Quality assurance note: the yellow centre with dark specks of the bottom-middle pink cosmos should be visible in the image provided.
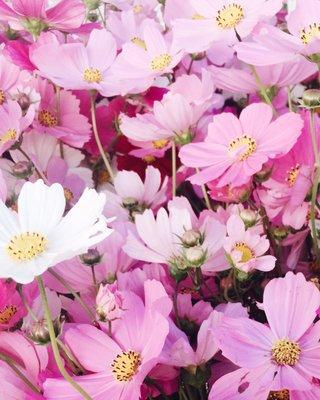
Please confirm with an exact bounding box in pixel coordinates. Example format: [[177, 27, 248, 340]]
[[111, 350, 141, 382]]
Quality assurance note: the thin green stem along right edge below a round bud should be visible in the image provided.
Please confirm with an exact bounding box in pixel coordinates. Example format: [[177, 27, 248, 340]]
[[310, 110, 320, 265]]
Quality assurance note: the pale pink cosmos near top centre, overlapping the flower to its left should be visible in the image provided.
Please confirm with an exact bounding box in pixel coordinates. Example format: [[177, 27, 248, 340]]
[[112, 23, 183, 95]]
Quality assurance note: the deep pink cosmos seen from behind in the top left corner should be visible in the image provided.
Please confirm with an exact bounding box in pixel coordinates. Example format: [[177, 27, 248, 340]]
[[0, 0, 85, 35]]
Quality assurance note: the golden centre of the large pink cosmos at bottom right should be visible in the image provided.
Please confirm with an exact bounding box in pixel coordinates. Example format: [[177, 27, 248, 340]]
[[271, 339, 301, 367]]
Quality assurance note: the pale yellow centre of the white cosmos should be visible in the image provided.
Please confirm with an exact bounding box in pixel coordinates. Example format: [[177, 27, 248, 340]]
[[6, 232, 47, 261]]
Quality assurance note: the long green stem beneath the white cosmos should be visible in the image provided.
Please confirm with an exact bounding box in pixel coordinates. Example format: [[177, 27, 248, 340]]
[[37, 276, 92, 400]]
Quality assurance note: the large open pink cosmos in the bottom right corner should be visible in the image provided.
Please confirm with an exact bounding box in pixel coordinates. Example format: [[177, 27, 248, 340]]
[[216, 272, 320, 391]]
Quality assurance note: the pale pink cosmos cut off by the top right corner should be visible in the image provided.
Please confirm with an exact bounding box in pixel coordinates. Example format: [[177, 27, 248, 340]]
[[235, 0, 320, 65]]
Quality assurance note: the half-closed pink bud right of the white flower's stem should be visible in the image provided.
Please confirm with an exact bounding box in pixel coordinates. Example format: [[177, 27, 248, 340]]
[[96, 284, 124, 321]]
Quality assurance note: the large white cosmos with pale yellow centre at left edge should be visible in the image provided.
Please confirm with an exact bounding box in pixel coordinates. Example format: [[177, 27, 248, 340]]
[[0, 180, 112, 283]]
